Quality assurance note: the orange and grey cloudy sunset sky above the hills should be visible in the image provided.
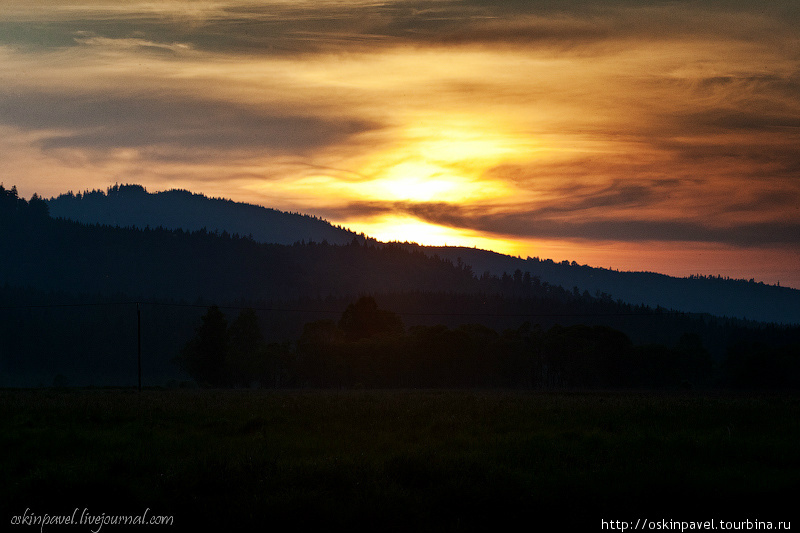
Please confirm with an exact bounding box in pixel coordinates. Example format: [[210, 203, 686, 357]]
[[0, 0, 800, 288]]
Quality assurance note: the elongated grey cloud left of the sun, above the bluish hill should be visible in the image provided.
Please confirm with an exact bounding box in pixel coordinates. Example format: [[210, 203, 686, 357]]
[[0, 92, 375, 158]]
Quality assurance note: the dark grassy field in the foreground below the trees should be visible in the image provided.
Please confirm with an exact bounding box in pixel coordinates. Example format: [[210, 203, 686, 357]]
[[0, 390, 800, 531]]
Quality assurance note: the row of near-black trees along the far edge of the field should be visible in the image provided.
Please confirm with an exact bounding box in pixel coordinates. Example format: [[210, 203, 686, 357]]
[[176, 297, 800, 389]]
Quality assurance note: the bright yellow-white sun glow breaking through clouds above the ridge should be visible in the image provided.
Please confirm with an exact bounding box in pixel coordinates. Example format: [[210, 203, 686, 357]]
[[245, 115, 542, 249]]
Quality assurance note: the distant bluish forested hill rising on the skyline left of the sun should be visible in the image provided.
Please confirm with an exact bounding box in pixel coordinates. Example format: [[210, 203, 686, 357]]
[[47, 185, 364, 244]]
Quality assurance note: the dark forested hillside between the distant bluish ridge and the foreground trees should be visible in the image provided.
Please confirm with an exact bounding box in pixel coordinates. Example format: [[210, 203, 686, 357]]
[[0, 186, 798, 386]]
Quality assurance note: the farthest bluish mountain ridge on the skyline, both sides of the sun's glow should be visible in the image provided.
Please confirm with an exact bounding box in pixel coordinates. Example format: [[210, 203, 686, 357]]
[[47, 185, 800, 324]]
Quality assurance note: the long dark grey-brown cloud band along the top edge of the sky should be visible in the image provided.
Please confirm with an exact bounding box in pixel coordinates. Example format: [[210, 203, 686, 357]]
[[0, 0, 800, 54]]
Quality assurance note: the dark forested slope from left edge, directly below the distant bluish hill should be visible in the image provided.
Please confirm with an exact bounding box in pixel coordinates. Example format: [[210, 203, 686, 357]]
[[0, 199, 478, 302]]
